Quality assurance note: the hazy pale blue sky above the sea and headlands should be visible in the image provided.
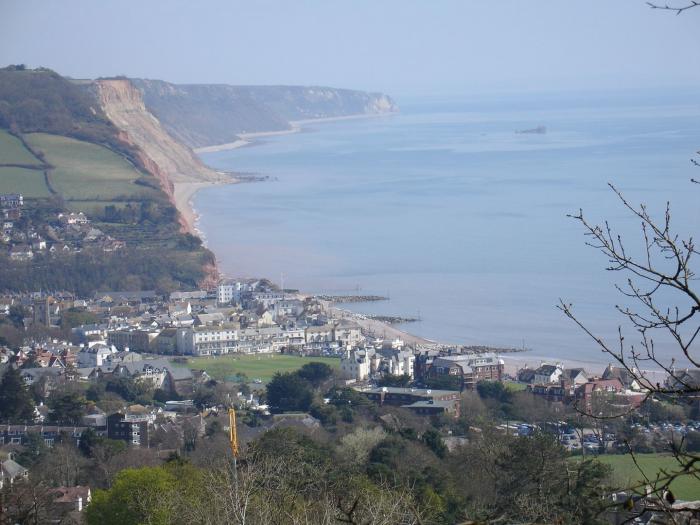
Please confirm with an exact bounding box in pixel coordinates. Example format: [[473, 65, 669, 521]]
[[0, 0, 700, 94]]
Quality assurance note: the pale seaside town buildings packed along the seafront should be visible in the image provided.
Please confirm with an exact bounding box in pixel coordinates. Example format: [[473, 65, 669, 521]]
[[0, 278, 680, 454]]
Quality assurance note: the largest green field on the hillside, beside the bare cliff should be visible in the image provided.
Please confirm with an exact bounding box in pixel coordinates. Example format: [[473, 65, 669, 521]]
[[25, 133, 155, 202]]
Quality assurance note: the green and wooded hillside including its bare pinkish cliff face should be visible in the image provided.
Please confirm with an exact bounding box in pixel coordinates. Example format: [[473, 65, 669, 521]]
[[0, 66, 223, 295]]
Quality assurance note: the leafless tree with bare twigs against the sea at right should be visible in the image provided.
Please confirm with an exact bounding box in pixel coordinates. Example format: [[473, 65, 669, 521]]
[[559, 185, 700, 510]]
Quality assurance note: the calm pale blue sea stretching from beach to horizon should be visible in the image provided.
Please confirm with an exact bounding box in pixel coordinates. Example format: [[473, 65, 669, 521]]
[[195, 95, 700, 361]]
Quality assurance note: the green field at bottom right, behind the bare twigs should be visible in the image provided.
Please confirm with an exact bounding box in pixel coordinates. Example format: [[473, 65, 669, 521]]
[[598, 454, 700, 500]]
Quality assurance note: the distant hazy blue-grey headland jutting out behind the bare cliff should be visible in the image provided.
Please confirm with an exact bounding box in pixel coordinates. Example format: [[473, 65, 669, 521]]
[[132, 79, 398, 148]]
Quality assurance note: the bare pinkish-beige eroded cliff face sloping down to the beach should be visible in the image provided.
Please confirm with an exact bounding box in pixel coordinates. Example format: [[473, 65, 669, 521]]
[[96, 79, 226, 186]]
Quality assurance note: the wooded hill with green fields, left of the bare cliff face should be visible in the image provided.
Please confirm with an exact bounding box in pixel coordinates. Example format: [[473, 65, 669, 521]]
[[0, 66, 213, 294]]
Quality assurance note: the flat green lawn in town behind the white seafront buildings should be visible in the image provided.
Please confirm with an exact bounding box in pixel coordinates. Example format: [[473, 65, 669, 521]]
[[178, 354, 340, 382]]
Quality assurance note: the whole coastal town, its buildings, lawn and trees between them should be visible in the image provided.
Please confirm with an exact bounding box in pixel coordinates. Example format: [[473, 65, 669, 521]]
[[0, 270, 700, 513]]
